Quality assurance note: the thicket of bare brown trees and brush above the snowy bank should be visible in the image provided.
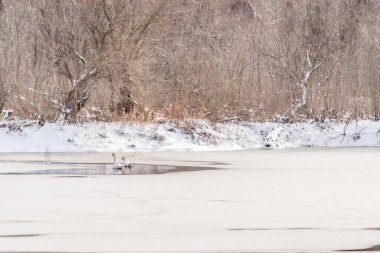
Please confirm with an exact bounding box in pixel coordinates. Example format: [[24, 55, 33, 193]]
[[0, 0, 380, 121]]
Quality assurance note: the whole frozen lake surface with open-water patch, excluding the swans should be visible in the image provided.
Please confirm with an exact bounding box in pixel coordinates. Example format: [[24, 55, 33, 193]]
[[0, 148, 380, 252]]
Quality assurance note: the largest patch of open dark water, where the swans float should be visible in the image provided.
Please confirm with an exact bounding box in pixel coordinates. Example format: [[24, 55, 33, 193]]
[[0, 163, 218, 177]]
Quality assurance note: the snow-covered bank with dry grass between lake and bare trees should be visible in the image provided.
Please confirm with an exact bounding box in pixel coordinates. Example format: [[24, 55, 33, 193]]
[[0, 120, 380, 152]]
